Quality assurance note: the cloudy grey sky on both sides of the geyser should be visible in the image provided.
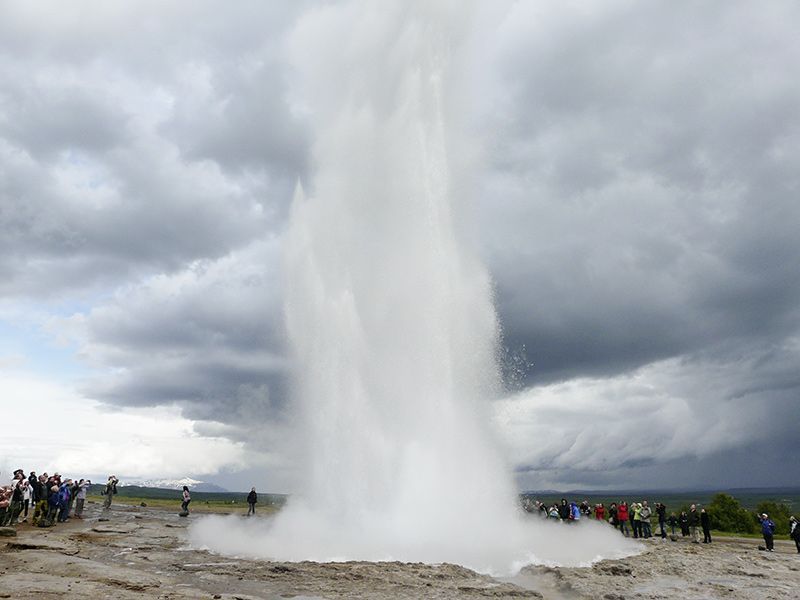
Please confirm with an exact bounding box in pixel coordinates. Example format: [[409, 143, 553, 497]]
[[0, 0, 800, 492]]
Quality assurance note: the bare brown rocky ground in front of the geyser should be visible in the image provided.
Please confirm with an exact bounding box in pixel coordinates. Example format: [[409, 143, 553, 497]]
[[0, 505, 800, 600]]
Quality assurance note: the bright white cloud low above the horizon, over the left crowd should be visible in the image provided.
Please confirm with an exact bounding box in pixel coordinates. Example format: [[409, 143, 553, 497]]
[[0, 371, 247, 477]]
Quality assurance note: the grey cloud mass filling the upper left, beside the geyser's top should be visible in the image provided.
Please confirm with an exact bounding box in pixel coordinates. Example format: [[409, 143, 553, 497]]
[[0, 2, 306, 296]]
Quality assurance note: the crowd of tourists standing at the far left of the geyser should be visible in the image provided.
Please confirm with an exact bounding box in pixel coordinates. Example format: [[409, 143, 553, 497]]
[[0, 469, 118, 527]]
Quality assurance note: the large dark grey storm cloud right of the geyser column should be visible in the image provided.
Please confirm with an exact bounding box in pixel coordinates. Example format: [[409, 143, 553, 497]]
[[478, 3, 800, 382]]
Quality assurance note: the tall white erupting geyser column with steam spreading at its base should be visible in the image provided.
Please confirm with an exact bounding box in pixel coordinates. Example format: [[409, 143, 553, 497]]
[[192, 2, 630, 572]]
